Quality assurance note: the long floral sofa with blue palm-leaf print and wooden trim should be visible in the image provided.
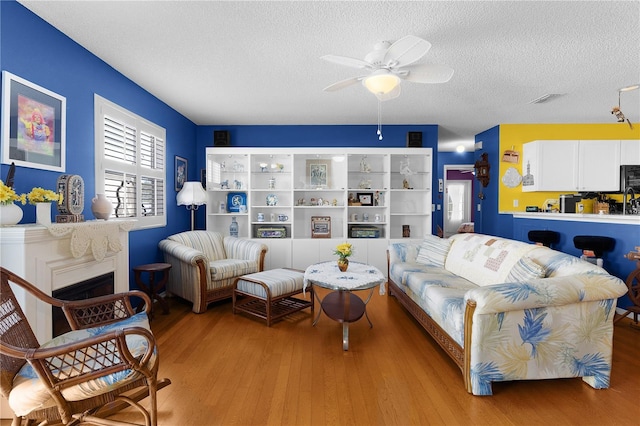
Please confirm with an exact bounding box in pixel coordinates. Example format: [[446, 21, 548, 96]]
[[387, 233, 627, 395]]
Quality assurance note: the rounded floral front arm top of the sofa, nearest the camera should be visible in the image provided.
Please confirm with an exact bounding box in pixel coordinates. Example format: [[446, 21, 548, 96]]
[[465, 274, 627, 314]]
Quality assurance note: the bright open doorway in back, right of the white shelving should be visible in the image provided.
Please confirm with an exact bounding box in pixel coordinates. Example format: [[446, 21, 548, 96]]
[[442, 164, 474, 238]]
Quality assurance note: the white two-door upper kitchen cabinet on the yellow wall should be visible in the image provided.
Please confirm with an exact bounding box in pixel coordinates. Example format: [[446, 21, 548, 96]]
[[522, 140, 621, 192]]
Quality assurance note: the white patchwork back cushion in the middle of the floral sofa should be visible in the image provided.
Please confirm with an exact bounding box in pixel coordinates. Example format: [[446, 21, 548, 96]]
[[445, 234, 537, 286]]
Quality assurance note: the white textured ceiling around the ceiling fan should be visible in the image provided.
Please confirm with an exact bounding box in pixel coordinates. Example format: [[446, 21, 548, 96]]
[[19, 0, 640, 151]]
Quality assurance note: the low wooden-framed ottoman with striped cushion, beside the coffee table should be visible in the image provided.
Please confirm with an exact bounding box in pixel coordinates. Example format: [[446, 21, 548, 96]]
[[232, 268, 313, 327]]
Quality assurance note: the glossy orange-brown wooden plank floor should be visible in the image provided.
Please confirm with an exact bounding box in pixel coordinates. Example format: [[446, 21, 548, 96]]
[[7, 291, 640, 425]]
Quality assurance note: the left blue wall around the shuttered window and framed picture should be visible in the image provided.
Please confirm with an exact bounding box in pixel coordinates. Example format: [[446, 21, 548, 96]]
[[0, 1, 200, 280]]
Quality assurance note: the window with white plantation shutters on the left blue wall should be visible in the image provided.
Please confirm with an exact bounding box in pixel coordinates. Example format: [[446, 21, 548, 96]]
[[94, 95, 166, 228]]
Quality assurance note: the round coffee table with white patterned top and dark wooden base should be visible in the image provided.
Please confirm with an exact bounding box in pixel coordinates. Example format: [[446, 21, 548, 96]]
[[304, 261, 386, 351]]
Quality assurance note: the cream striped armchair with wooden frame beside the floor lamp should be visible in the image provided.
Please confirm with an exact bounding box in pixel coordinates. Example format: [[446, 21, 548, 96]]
[[158, 231, 267, 314]]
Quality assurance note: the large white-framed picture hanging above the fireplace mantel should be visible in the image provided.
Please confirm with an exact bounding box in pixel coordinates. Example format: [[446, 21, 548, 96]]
[[1, 71, 67, 172]]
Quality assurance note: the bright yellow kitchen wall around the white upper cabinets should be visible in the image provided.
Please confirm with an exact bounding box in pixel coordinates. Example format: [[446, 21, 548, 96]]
[[498, 123, 640, 212]]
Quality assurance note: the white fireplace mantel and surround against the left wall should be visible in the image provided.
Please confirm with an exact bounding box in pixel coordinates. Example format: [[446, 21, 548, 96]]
[[0, 219, 136, 343]]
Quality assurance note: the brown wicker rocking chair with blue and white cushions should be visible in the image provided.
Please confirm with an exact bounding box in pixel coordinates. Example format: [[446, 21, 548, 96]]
[[0, 267, 171, 426]]
